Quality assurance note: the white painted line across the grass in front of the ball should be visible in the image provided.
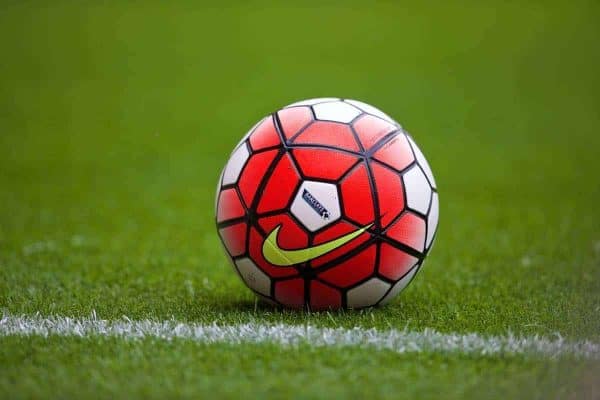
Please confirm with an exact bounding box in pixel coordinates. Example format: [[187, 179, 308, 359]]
[[0, 314, 600, 359]]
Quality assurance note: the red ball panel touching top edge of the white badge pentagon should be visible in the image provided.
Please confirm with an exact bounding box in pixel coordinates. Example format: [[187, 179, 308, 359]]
[[292, 148, 358, 180]]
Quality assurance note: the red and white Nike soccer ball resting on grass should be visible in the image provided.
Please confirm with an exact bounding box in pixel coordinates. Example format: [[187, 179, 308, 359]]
[[216, 98, 439, 310]]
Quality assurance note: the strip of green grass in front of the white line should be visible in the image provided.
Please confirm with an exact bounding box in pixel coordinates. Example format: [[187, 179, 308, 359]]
[[0, 337, 600, 399]]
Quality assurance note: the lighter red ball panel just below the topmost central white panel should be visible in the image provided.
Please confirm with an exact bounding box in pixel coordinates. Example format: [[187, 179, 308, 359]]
[[294, 121, 359, 151]]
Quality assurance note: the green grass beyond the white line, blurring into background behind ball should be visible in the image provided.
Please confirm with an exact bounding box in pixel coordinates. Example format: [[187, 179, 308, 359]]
[[0, 1, 600, 336]]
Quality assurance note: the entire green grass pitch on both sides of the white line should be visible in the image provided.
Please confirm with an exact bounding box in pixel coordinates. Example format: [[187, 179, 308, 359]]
[[0, 1, 600, 399]]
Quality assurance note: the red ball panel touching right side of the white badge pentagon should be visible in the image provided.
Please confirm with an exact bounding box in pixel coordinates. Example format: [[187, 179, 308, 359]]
[[341, 164, 375, 225]]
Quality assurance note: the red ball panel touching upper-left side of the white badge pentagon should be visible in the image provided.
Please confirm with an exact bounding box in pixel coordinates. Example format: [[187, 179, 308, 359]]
[[257, 154, 300, 213]]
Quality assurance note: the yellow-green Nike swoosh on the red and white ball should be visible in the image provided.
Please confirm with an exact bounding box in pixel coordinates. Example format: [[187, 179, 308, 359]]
[[262, 224, 373, 267]]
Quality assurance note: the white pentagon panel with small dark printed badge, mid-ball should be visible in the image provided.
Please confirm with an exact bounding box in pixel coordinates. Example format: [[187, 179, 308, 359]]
[[291, 181, 341, 232]]
